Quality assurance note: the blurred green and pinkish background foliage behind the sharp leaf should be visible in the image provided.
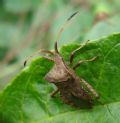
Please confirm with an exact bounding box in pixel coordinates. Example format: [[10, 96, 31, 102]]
[[0, 0, 120, 88]]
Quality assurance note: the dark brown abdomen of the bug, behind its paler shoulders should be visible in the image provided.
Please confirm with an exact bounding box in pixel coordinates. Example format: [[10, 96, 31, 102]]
[[56, 79, 92, 108]]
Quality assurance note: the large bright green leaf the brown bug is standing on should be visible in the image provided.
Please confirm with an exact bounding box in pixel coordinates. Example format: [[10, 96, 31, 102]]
[[0, 33, 120, 123]]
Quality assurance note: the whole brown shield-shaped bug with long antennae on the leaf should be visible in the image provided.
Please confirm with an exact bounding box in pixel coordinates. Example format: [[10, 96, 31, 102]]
[[24, 12, 99, 108]]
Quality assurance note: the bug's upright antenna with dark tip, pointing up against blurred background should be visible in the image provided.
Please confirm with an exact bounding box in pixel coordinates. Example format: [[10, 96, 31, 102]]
[[54, 11, 78, 53]]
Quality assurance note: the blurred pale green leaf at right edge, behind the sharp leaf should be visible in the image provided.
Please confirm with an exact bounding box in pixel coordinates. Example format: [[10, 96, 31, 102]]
[[84, 14, 120, 40]]
